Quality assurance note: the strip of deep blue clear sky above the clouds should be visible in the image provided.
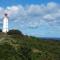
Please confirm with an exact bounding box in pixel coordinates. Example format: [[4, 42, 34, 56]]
[[0, 0, 60, 7]]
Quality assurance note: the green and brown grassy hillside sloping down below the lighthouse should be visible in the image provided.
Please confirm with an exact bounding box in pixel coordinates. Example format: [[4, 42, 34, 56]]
[[0, 30, 60, 60]]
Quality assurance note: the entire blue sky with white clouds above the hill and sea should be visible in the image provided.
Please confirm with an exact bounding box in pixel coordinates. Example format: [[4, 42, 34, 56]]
[[0, 0, 60, 38]]
